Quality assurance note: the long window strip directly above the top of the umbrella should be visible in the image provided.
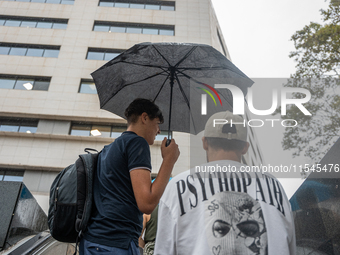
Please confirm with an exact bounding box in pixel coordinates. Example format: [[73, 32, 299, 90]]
[[93, 21, 175, 36]]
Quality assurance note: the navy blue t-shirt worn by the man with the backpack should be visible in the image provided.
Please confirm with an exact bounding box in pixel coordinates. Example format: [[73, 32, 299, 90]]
[[84, 131, 151, 249]]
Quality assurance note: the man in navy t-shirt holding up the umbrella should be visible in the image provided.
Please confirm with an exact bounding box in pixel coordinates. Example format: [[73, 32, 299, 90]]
[[79, 99, 179, 255]]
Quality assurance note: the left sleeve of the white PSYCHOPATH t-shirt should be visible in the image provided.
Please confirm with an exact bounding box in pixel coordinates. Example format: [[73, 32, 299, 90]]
[[154, 200, 177, 255]]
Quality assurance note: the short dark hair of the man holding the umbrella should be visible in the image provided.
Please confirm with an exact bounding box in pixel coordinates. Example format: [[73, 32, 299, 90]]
[[124, 98, 164, 125]]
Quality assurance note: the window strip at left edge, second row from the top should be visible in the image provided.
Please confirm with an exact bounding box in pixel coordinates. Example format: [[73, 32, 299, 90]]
[[0, 15, 67, 29]]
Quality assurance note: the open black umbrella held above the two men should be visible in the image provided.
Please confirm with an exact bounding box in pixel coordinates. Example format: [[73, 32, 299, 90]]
[[91, 43, 253, 138]]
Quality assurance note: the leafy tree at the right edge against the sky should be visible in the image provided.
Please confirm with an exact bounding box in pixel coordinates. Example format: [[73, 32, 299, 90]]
[[276, 0, 340, 162]]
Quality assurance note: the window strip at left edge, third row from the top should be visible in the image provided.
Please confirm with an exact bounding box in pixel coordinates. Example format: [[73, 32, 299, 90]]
[[0, 43, 60, 58]]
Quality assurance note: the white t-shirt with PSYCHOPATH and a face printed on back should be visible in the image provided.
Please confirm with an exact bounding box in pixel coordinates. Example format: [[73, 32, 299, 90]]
[[155, 160, 296, 255]]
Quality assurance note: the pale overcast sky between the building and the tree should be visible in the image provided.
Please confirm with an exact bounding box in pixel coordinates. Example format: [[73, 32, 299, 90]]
[[212, 0, 328, 198]]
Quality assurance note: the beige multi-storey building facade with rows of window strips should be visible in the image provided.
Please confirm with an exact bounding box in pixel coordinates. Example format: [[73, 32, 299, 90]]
[[0, 0, 262, 211]]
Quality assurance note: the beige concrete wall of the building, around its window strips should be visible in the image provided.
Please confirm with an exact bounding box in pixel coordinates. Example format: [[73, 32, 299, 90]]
[[0, 0, 234, 213]]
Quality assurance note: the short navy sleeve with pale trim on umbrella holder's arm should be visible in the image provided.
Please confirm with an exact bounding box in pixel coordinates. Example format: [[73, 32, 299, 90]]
[[127, 137, 151, 172]]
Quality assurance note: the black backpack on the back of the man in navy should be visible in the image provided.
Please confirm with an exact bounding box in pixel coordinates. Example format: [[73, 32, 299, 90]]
[[48, 148, 100, 247]]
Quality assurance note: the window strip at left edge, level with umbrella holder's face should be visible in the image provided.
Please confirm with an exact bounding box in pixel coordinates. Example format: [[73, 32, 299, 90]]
[[0, 117, 38, 134]]
